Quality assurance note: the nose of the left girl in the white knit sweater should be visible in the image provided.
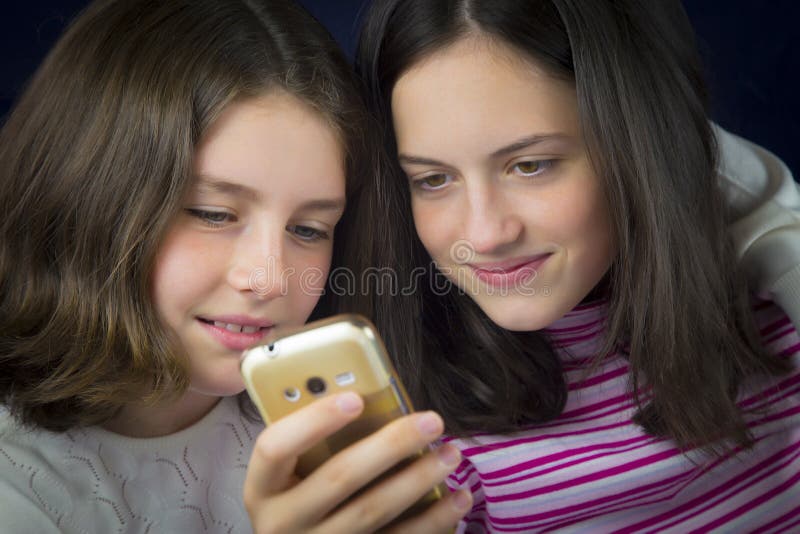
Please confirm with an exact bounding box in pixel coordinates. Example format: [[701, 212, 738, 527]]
[[228, 224, 292, 300]]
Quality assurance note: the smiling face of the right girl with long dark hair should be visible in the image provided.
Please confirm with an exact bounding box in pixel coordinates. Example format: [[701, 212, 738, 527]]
[[391, 38, 614, 331]]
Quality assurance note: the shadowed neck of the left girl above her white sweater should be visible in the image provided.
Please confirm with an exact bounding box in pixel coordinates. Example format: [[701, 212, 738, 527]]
[[101, 390, 221, 438]]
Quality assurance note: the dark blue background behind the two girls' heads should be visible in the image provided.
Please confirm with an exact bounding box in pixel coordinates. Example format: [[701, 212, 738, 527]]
[[0, 0, 800, 178]]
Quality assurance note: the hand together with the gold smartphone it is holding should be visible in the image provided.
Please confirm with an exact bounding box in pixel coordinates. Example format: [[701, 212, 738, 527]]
[[242, 316, 470, 532]]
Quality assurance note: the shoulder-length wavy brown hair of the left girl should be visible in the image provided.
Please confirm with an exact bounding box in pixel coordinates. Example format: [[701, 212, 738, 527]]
[[0, 0, 374, 430]]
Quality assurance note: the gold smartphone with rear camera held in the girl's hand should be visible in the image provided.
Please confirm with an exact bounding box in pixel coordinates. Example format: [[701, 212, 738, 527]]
[[241, 315, 447, 521]]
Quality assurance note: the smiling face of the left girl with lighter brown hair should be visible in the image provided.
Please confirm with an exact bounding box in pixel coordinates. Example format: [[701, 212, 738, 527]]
[[153, 93, 345, 398]]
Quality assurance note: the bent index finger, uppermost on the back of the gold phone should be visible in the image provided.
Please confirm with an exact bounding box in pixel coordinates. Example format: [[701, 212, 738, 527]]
[[245, 392, 364, 502]]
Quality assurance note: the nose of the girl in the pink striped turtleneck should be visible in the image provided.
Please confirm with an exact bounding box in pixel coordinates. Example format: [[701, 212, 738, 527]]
[[464, 182, 523, 255]]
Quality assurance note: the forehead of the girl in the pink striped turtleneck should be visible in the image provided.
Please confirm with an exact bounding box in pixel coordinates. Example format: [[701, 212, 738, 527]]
[[392, 38, 579, 153]]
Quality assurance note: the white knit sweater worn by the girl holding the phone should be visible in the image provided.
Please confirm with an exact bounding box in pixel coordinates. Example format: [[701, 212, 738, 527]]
[[0, 397, 263, 534]]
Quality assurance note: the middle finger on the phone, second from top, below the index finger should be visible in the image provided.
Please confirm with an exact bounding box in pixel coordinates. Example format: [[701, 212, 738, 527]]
[[291, 412, 444, 519]]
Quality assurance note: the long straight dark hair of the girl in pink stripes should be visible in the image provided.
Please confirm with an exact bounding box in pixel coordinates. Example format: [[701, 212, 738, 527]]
[[357, 0, 786, 448]]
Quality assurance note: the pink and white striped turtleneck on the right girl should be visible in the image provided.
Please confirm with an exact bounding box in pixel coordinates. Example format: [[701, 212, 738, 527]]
[[448, 302, 800, 533]]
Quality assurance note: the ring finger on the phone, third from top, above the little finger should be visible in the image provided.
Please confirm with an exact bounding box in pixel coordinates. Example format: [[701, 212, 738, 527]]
[[312, 444, 461, 532]]
